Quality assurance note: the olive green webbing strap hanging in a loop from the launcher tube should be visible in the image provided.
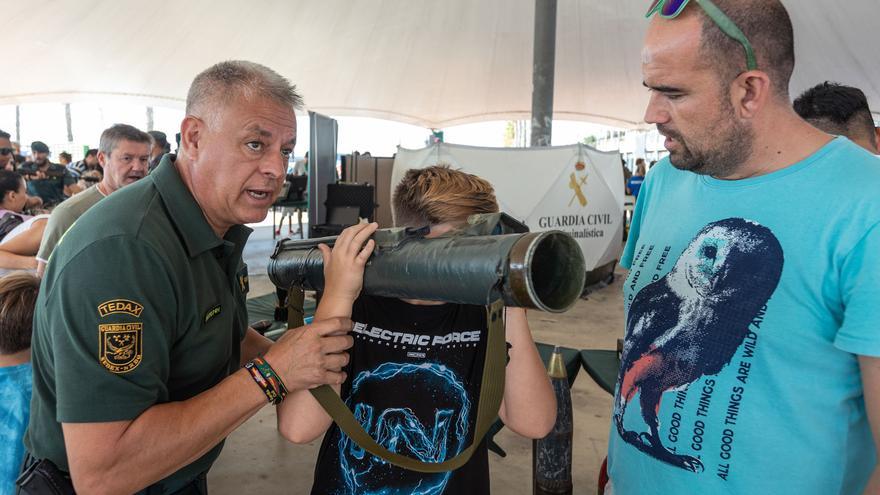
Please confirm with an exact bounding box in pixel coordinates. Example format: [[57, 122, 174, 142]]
[[311, 300, 507, 473]]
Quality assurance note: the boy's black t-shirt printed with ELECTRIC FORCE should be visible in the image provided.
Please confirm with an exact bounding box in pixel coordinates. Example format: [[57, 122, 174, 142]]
[[312, 295, 489, 495]]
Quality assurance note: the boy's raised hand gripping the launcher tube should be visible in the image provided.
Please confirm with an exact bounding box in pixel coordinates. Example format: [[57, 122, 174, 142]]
[[318, 222, 379, 308]]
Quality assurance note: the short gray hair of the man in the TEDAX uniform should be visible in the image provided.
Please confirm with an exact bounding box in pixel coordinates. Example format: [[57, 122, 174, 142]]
[[186, 60, 303, 115]]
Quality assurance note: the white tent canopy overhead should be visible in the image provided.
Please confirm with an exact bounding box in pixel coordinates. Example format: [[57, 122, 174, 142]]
[[0, 0, 880, 128]]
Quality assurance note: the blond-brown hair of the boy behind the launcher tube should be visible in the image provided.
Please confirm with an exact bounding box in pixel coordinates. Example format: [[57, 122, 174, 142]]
[[391, 165, 498, 227]]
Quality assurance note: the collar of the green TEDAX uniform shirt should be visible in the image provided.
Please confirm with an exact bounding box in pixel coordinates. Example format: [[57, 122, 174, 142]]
[[150, 153, 253, 257]]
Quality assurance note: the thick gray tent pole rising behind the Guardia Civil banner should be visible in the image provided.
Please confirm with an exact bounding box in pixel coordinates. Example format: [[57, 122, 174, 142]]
[[532, 0, 556, 147]]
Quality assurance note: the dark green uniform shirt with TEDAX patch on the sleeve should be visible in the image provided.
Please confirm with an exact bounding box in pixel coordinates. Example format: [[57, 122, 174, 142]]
[[25, 155, 251, 489]]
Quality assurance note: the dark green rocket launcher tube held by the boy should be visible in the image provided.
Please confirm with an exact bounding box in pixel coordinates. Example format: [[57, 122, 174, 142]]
[[269, 214, 586, 313]]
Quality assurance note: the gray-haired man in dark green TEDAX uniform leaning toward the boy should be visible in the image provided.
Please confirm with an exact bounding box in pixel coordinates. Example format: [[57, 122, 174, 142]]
[[25, 62, 352, 494]]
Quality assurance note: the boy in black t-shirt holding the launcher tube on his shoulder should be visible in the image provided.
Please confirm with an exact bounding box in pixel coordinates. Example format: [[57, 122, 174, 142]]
[[278, 165, 556, 495]]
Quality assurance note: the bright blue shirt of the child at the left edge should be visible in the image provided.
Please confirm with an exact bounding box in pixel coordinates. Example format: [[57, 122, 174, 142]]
[[0, 363, 33, 495]]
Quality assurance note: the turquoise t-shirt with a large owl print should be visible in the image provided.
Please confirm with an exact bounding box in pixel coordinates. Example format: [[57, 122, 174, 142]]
[[608, 138, 880, 495]]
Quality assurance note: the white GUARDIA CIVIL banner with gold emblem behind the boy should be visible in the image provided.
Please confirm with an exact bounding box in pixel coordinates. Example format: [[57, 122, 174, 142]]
[[391, 143, 624, 270]]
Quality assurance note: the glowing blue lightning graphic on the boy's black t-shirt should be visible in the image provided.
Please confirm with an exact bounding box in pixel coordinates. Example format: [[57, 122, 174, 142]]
[[338, 363, 471, 495]]
